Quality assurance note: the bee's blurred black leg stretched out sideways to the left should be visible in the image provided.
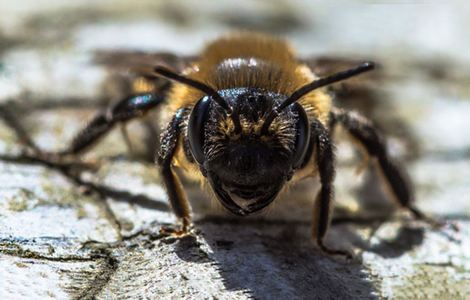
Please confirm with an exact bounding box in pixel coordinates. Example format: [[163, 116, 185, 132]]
[[59, 93, 164, 156]]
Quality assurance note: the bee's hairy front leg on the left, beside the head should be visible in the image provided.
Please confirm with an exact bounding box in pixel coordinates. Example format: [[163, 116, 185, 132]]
[[157, 108, 191, 237]]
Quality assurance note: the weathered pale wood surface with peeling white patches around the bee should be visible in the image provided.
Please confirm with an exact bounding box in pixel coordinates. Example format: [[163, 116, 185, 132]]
[[0, 1, 470, 299]]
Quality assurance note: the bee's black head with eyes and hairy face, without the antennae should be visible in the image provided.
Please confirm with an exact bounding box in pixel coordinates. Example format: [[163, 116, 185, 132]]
[[189, 88, 308, 216]]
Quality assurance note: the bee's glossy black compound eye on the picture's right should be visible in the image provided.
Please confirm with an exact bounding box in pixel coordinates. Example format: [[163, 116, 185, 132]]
[[292, 103, 310, 169]]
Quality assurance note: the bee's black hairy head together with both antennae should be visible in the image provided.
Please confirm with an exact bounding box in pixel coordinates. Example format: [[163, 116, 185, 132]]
[[154, 62, 374, 216]]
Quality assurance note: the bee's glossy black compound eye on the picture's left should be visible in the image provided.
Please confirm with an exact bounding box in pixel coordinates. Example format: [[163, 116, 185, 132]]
[[188, 96, 211, 165]]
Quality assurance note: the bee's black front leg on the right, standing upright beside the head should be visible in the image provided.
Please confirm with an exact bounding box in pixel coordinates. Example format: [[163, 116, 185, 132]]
[[311, 120, 352, 258]]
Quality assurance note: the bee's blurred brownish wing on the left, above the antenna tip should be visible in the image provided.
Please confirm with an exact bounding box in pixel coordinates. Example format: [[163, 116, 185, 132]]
[[94, 51, 195, 76]]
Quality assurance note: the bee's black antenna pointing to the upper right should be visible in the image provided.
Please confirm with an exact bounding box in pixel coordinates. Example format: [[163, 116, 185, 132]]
[[261, 62, 375, 134]]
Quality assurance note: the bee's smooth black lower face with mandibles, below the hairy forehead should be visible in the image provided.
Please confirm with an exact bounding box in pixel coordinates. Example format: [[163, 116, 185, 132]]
[[207, 141, 290, 215]]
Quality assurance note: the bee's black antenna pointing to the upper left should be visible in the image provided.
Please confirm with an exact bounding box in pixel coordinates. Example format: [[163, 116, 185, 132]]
[[153, 66, 232, 115]]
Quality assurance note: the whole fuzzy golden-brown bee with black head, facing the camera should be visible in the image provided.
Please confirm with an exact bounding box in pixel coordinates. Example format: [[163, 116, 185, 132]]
[[33, 33, 434, 255]]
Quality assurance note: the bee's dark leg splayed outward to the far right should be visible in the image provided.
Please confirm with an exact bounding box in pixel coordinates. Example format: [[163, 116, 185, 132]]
[[330, 108, 450, 226]]
